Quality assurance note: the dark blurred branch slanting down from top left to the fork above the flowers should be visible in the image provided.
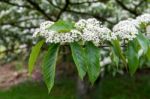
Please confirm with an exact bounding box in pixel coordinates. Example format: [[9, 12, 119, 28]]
[[27, 0, 53, 21]]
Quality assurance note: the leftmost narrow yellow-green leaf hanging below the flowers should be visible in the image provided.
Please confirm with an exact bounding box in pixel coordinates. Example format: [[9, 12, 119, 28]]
[[28, 40, 44, 74]]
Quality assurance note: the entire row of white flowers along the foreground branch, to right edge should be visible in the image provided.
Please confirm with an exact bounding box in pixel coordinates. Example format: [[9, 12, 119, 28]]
[[33, 14, 150, 46]]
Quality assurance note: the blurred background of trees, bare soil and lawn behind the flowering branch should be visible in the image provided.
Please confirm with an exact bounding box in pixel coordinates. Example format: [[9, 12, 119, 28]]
[[0, 0, 150, 99]]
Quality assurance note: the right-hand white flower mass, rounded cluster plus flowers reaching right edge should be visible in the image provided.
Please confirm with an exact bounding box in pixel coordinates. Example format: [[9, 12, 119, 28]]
[[113, 14, 150, 40]]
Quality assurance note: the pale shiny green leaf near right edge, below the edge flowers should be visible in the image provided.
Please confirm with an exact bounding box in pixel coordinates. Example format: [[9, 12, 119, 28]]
[[137, 33, 148, 53]]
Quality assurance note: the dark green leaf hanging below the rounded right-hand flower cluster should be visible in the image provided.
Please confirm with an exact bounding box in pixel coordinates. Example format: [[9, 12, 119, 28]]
[[127, 42, 139, 75]]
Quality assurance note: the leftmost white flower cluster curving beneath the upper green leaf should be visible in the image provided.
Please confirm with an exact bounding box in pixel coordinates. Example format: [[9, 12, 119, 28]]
[[33, 21, 81, 44]]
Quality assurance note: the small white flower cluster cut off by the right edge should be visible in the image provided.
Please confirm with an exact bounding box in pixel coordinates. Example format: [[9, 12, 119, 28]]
[[136, 14, 150, 24]]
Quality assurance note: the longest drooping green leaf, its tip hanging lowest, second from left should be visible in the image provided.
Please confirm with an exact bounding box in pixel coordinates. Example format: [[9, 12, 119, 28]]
[[42, 44, 59, 92]]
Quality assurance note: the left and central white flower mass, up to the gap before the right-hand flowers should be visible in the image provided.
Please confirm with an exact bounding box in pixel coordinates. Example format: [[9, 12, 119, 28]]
[[33, 18, 116, 46]]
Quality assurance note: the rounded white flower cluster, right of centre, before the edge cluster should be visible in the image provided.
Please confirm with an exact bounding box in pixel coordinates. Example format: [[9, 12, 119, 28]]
[[113, 19, 138, 40]]
